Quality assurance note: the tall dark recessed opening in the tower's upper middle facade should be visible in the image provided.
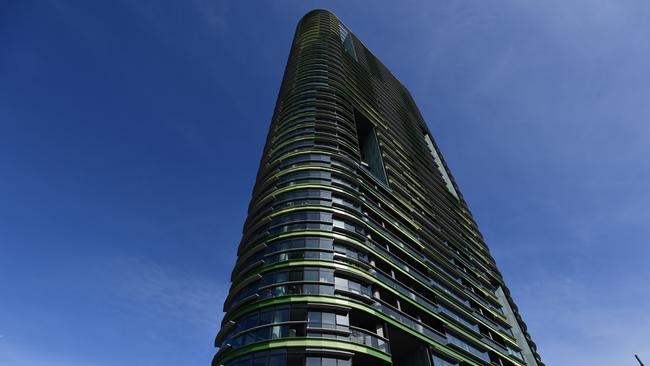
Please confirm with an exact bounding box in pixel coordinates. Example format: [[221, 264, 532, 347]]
[[354, 108, 388, 184]]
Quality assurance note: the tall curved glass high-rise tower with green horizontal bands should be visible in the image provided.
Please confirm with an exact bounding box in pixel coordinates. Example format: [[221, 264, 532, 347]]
[[213, 10, 543, 366]]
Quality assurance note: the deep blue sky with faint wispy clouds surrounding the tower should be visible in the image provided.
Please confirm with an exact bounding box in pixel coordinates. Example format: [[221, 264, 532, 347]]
[[0, 0, 650, 366]]
